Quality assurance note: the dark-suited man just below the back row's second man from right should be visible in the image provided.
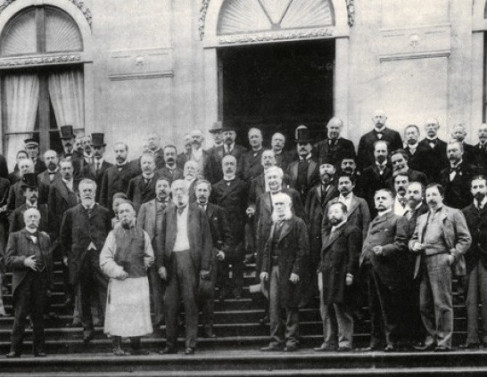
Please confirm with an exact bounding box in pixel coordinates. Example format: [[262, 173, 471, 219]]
[[440, 140, 475, 209]]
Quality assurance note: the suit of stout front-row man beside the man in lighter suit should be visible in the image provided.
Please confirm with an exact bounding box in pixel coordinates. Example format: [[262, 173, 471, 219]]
[[360, 212, 412, 347]]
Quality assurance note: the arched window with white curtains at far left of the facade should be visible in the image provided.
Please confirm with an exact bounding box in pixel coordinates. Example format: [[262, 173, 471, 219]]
[[0, 6, 85, 161]]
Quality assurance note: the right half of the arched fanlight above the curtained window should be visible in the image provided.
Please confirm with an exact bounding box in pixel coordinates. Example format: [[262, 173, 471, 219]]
[[45, 7, 83, 52]]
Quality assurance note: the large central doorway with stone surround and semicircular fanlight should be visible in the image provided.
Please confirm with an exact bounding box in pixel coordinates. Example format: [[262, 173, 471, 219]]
[[204, 0, 349, 146]]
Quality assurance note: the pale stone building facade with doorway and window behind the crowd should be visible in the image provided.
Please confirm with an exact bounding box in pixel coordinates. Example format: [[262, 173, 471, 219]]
[[0, 0, 487, 159]]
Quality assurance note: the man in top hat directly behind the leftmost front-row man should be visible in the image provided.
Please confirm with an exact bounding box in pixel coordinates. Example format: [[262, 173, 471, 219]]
[[9, 173, 48, 233]]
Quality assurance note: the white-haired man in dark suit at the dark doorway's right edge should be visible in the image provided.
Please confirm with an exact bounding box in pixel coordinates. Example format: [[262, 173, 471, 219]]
[[315, 117, 355, 166]]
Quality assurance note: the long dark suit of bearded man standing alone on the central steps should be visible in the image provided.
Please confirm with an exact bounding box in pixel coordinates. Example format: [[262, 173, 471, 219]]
[[210, 178, 248, 293]]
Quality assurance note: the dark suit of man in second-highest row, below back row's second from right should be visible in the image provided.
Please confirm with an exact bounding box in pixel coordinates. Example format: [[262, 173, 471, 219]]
[[440, 162, 475, 209]]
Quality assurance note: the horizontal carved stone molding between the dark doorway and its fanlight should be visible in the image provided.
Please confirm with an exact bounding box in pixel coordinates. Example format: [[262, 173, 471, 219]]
[[218, 28, 334, 45]]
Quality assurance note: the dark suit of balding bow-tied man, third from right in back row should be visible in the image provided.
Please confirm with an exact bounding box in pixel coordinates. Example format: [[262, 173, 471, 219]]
[[410, 139, 448, 183]]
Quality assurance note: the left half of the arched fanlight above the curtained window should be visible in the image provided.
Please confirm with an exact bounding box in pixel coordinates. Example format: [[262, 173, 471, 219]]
[[0, 8, 37, 56]]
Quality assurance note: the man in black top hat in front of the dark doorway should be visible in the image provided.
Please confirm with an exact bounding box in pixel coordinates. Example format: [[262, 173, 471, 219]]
[[287, 128, 320, 203]]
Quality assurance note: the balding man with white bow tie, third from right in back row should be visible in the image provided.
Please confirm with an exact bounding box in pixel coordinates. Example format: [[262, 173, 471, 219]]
[[415, 118, 448, 183]]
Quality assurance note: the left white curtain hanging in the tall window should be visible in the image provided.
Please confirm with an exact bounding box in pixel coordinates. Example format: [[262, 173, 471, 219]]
[[5, 74, 39, 164]]
